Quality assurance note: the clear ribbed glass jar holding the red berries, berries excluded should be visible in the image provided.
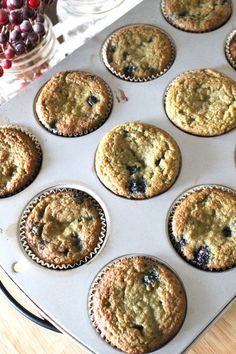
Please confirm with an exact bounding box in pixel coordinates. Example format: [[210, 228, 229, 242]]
[[0, 16, 57, 104]]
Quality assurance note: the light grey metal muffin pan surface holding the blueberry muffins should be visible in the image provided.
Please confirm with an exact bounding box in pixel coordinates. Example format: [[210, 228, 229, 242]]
[[0, 0, 236, 354]]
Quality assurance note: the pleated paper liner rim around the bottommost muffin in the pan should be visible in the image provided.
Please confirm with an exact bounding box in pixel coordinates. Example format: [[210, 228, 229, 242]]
[[88, 253, 188, 352]]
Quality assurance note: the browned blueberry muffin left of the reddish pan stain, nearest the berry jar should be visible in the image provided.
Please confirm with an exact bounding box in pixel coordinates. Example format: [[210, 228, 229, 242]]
[[35, 71, 112, 136]]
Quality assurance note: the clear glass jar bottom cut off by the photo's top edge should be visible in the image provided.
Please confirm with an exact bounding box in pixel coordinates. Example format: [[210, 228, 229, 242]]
[[60, 0, 124, 14]]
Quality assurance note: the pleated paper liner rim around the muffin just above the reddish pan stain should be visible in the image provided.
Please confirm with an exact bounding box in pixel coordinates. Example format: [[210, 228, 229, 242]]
[[101, 23, 176, 82]]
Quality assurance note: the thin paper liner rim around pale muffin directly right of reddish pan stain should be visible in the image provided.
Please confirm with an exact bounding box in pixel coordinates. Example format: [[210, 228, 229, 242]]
[[163, 69, 235, 138]]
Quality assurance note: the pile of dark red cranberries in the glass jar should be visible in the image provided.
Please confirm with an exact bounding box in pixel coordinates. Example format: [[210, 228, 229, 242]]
[[0, 0, 53, 77]]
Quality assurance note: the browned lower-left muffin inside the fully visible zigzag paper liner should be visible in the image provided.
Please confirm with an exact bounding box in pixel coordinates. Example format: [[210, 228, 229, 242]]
[[23, 190, 105, 266]]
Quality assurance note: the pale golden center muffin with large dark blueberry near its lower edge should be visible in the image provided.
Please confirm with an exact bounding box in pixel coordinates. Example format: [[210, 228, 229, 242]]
[[95, 122, 181, 199]]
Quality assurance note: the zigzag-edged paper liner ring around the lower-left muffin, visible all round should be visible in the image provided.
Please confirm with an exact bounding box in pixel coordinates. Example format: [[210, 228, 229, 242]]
[[19, 186, 108, 270]]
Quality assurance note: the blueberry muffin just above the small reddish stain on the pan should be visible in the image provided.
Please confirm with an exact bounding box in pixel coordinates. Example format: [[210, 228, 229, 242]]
[[103, 25, 175, 81]]
